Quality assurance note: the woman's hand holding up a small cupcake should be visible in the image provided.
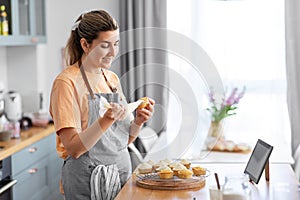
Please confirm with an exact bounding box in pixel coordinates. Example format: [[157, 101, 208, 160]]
[[134, 98, 155, 126]]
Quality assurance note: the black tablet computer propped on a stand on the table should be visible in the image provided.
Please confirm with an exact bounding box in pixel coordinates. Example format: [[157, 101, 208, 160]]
[[244, 139, 273, 184]]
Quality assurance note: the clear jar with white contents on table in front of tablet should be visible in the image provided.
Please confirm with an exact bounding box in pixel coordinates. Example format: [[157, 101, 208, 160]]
[[223, 175, 251, 200]]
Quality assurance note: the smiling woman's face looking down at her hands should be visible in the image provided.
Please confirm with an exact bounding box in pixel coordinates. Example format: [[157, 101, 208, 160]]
[[87, 30, 120, 69]]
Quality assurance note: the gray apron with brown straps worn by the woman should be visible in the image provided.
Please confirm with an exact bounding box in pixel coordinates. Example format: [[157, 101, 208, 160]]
[[62, 67, 131, 200]]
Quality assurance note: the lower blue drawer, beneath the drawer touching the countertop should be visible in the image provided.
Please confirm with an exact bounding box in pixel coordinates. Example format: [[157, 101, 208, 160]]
[[13, 158, 50, 200]]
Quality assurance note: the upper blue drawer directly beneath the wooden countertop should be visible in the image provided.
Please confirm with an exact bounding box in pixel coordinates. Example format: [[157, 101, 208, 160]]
[[11, 135, 55, 176]]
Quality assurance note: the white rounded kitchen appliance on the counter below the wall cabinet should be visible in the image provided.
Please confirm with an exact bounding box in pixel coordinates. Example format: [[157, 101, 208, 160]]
[[4, 91, 22, 121]]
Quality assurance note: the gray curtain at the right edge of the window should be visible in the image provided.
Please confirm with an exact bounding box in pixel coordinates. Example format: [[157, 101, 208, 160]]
[[285, 0, 300, 153]]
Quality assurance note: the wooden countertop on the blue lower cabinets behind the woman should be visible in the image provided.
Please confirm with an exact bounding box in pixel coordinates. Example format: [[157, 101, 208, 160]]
[[0, 124, 55, 160]]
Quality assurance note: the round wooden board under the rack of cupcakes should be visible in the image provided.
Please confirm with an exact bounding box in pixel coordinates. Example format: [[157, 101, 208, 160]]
[[136, 175, 205, 190]]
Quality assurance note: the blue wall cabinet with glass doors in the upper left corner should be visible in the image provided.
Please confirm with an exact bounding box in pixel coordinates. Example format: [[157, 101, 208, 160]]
[[0, 0, 46, 46]]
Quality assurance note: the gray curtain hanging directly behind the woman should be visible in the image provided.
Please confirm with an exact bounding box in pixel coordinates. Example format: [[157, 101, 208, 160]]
[[116, 0, 168, 134]]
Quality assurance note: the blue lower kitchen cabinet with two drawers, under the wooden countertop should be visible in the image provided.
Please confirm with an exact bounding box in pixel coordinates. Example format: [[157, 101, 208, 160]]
[[12, 134, 63, 200]]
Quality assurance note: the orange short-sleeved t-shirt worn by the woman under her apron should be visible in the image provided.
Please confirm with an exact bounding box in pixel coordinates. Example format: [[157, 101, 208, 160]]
[[50, 65, 124, 159]]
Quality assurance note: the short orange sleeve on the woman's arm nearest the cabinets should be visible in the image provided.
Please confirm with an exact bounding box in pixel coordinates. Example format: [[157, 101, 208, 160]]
[[50, 79, 81, 132]]
